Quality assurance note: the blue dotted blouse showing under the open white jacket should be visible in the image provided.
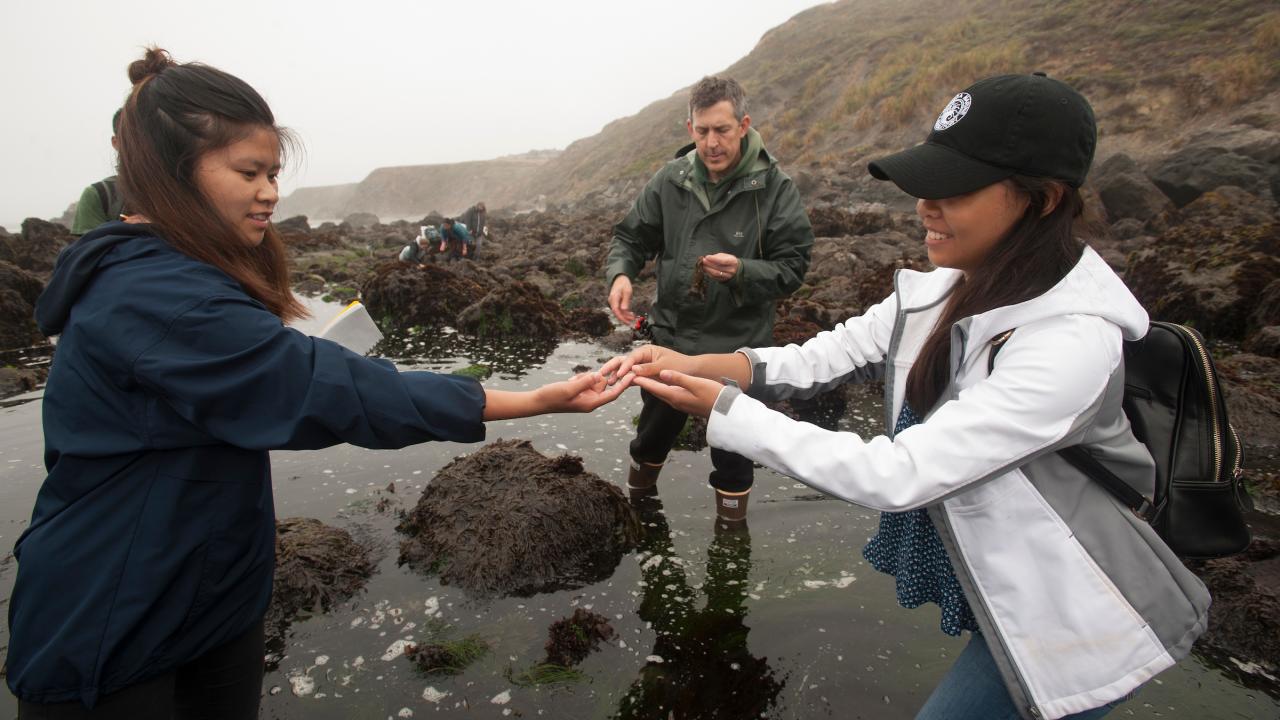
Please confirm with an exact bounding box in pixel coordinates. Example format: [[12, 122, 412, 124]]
[[863, 405, 978, 635]]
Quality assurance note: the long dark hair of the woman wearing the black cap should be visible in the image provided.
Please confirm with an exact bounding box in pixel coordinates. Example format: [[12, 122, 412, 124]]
[[906, 176, 1084, 415]]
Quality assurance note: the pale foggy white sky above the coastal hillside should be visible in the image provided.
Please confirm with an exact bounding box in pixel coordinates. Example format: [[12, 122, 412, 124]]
[[0, 0, 820, 232]]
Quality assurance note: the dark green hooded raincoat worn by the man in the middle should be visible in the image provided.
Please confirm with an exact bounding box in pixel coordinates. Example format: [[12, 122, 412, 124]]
[[605, 129, 813, 354]]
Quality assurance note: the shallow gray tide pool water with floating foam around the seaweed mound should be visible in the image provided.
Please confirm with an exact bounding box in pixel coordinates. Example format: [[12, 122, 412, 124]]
[[0, 324, 1280, 720]]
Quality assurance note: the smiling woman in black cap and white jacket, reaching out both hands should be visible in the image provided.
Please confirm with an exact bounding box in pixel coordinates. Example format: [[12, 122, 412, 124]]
[[603, 73, 1208, 720]]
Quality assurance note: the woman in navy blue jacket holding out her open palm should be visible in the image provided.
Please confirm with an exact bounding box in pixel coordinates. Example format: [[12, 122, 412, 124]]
[[8, 49, 630, 720]]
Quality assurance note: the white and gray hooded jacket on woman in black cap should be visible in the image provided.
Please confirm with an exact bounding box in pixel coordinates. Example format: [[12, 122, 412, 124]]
[[707, 249, 1210, 717]]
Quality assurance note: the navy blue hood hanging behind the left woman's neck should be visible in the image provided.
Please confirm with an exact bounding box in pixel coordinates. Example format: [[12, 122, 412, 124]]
[[36, 222, 155, 336]]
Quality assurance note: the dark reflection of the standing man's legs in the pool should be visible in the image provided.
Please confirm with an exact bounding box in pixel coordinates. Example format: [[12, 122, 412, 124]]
[[616, 495, 785, 720]]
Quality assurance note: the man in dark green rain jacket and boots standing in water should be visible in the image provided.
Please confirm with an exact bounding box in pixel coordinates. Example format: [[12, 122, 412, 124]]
[[605, 77, 813, 520]]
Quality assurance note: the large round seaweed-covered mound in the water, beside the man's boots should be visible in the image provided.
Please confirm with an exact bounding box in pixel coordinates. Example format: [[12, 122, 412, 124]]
[[398, 441, 640, 597]]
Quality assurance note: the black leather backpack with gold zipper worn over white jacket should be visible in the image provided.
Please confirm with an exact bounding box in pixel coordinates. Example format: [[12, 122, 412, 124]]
[[987, 322, 1251, 560]]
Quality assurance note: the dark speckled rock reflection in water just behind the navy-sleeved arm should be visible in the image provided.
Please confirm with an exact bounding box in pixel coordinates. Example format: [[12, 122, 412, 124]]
[[371, 327, 557, 379]]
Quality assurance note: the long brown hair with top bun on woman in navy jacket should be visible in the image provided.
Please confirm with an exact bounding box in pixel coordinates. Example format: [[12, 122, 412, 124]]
[[116, 47, 307, 320]]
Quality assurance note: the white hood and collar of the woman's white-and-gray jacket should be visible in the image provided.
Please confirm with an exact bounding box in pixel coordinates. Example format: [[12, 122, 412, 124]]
[[896, 246, 1151, 361]]
